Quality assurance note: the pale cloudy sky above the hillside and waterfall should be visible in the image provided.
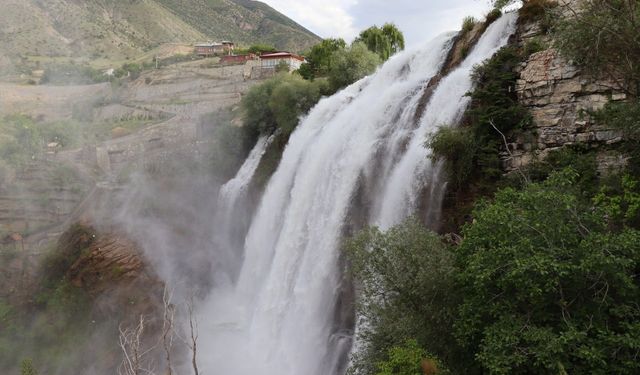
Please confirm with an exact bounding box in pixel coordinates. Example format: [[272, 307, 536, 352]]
[[262, 0, 491, 46]]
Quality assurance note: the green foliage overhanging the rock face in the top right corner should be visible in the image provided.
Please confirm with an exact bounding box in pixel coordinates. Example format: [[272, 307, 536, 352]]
[[554, 0, 640, 97]]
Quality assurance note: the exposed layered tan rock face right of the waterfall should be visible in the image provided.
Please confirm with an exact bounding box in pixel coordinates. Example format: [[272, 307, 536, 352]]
[[502, 18, 626, 172]]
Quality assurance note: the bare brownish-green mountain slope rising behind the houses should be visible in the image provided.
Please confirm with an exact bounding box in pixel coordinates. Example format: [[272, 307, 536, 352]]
[[0, 0, 318, 74]]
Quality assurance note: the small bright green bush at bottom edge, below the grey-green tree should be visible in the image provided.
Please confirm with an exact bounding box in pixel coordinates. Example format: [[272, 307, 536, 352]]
[[376, 340, 449, 375]]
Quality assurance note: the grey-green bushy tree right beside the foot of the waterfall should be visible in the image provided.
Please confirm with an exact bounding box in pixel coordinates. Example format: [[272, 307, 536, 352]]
[[345, 219, 457, 374]]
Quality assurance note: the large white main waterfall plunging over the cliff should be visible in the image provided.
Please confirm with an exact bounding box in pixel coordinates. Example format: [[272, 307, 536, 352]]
[[199, 11, 515, 375]]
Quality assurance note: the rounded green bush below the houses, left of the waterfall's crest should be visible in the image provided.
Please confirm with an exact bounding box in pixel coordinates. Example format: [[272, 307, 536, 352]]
[[241, 73, 328, 135]]
